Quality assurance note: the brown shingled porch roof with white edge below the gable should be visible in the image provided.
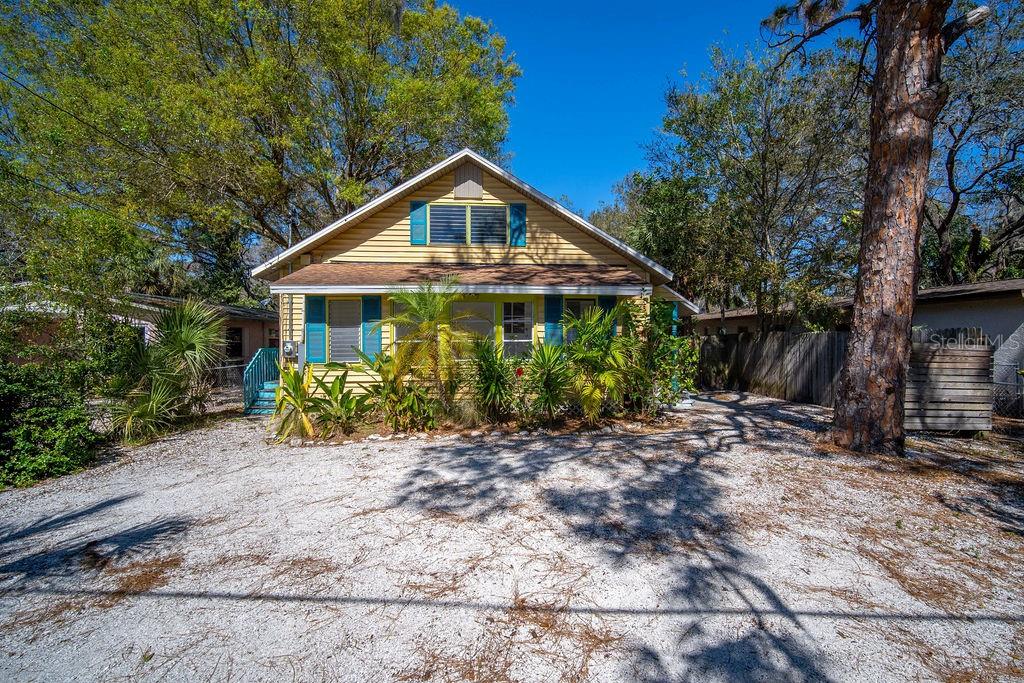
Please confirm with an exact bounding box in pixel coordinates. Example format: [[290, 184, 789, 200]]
[[270, 262, 651, 295]]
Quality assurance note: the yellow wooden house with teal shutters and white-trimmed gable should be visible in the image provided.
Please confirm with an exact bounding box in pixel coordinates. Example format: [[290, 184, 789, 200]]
[[253, 150, 696, 387]]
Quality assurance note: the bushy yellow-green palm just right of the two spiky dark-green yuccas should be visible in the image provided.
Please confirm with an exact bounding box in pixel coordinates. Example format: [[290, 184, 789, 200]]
[[565, 306, 628, 425]]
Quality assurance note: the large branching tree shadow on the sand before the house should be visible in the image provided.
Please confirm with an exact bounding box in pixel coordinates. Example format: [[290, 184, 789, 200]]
[[394, 397, 826, 681]]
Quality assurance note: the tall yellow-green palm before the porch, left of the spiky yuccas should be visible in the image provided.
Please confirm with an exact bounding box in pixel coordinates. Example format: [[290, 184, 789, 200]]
[[376, 276, 470, 414]]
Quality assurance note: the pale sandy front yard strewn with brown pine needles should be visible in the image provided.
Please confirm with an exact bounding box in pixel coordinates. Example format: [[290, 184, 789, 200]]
[[0, 394, 1024, 681]]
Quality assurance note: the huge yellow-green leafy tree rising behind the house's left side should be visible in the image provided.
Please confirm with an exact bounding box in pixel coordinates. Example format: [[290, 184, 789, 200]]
[[0, 0, 519, 299]]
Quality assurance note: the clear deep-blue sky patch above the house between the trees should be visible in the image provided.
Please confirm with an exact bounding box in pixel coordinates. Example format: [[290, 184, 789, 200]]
[[450, 0, 779, 211]]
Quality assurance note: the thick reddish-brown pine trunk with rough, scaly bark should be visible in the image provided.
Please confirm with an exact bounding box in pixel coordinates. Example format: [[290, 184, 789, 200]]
[[833, 0, 950, 454]]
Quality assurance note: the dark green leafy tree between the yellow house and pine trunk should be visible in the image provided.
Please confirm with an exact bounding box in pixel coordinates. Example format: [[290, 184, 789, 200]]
[[630, 43, 864, 327]]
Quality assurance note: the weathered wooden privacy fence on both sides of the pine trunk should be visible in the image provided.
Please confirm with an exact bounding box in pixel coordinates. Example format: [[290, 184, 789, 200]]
[[698, 332, 992, 431]]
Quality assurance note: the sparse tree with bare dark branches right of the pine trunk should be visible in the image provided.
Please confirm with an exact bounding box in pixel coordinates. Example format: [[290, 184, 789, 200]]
[[922, 0, 1024, 285]]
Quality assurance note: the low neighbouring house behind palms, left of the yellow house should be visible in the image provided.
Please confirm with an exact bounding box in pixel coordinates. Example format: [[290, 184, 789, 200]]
[[121, 294, 280, 366]]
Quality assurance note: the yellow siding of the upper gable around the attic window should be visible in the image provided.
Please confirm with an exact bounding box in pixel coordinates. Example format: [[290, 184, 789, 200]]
[[311, 167, 645, 273]]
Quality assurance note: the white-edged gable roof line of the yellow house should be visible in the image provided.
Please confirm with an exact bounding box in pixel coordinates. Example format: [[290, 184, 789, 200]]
[[252, 148, 672, 284]]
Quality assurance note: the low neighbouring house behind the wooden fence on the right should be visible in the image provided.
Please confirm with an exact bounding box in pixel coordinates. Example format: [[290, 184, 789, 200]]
[[691, 280, 1024, 384]]
